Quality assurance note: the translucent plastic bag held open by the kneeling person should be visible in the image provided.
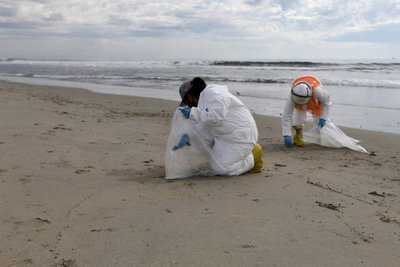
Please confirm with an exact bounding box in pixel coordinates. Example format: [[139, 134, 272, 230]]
[[165, 109, 222, 179]]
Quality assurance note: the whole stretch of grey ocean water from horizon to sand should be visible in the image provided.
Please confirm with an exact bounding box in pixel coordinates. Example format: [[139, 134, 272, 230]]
[[0, 59, 400, 133]]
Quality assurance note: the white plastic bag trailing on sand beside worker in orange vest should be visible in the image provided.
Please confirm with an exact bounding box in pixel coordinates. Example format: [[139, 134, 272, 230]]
[[303, 122, 368, 153]]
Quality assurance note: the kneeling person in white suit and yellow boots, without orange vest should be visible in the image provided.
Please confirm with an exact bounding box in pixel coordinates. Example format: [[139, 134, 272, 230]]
[[174, 77, 263, 175]]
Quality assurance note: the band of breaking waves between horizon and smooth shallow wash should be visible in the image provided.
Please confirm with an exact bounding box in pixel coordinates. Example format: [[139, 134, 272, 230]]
[[0, 58, 400, 88]]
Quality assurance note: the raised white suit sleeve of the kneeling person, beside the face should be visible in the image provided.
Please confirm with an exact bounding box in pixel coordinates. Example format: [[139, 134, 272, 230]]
[[190, 88, 230, 125]]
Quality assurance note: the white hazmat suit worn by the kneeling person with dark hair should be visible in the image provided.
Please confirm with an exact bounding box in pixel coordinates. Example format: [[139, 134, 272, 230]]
[[190, 84, 258, 175]]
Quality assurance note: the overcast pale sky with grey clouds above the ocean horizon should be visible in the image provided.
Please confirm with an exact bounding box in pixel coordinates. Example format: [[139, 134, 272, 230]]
[[0, 0, 400, 60]]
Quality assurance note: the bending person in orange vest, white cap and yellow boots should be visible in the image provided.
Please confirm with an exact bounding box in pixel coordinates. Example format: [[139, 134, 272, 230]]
[[282, 75, 332, 147]]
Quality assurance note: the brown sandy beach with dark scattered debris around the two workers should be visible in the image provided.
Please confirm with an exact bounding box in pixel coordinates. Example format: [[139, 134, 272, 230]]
[[0, 82, 400, 267]]
